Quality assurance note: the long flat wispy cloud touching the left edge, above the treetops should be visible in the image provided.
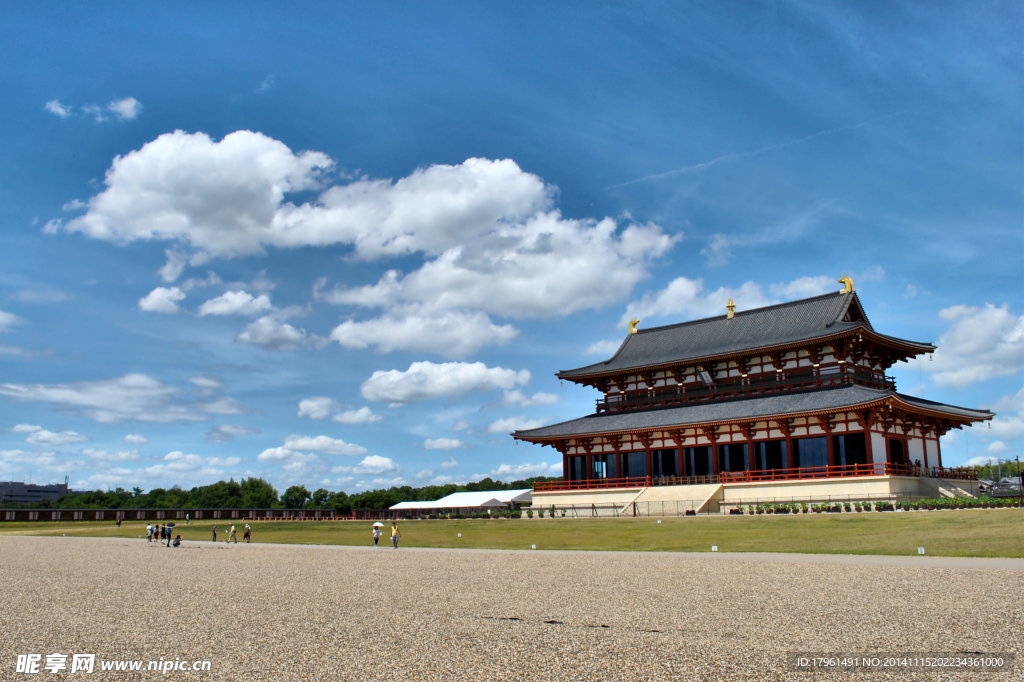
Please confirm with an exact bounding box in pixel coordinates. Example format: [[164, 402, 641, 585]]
[[0, 374, 207, 423]]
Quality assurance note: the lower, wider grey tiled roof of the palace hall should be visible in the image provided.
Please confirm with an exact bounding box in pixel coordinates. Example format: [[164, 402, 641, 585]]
[[512, 385, 992, 440]]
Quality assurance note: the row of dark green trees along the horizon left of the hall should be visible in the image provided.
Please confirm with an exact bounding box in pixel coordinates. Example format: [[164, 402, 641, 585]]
[[0, 476, 561, 514]]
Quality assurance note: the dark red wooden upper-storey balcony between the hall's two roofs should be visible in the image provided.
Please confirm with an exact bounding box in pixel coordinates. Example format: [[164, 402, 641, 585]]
[[597, 365, 896, 414]]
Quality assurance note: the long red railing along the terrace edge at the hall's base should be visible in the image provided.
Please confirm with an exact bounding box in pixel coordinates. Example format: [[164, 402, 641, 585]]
[[534, 463, 978, 493]]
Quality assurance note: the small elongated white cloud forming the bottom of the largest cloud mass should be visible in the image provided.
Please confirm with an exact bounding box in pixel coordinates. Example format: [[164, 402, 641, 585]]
[[331, 306, 519, 357]]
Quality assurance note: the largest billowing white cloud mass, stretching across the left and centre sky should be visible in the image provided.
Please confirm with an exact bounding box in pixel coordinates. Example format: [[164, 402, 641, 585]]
[[59, 131, 680, 356]]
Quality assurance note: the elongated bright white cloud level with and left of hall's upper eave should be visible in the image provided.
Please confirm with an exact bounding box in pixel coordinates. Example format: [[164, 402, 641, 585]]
[[360, 361, 530, 404]]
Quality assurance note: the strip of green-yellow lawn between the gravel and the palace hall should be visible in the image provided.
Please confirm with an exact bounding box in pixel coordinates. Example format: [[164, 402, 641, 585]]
[[0, 509, 1024, 557]]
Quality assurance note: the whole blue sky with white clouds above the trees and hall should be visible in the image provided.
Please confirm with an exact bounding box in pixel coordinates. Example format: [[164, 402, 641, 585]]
[[0, 2, 1024, 492]]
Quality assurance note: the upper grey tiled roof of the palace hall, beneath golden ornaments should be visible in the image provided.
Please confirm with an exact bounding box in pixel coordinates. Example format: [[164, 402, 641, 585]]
[[558, 292, 934, 379]]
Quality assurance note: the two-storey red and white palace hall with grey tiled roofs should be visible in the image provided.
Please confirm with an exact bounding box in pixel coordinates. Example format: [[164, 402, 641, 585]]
[[512, 278, 993, 503]]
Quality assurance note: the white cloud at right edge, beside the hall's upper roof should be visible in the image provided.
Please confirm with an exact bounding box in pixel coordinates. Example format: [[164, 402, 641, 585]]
[[921, 304, 1024, 387]]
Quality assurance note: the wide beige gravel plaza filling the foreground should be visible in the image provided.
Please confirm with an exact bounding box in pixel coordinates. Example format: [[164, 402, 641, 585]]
[[0, 537, 1024, 681]]
